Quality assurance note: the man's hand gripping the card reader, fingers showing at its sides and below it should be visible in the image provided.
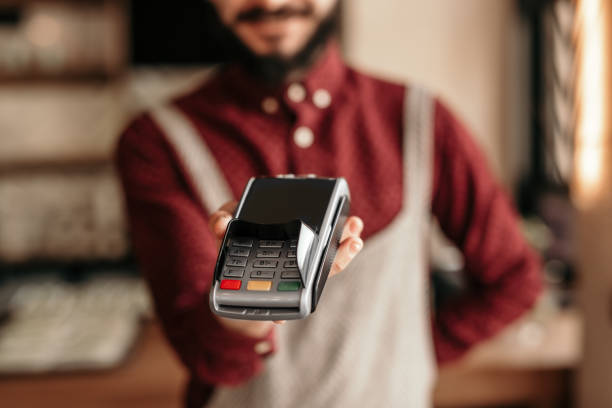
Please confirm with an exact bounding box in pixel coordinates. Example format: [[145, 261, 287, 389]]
[[209, 201, 363, 337]]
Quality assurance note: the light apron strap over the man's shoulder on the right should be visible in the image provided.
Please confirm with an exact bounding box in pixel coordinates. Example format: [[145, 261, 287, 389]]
[[403, 86, 434, 218]]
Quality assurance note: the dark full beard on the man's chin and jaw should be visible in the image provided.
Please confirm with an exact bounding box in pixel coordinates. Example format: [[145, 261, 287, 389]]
[[206, 5, 340, 85]]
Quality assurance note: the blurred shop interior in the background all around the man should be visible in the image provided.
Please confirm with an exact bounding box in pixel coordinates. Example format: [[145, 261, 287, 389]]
[[0, 0, 612, 408]]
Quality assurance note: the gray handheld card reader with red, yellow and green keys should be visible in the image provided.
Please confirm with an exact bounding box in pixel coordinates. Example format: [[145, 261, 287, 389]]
[[210, 175, 350, 320]]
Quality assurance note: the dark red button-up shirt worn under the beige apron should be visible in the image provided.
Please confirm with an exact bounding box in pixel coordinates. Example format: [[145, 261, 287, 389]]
[[116, 43, 541, 406]]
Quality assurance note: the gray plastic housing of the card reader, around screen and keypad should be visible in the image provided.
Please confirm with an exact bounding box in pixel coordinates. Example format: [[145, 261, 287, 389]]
[[209, 175, 350, 320]]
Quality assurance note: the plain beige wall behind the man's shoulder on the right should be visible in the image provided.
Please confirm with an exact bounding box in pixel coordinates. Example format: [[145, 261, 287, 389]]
[[343, 0, 528, 182]]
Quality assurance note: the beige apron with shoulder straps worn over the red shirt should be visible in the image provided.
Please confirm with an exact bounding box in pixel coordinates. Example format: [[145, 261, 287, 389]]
[[154, 88, 434, 408]]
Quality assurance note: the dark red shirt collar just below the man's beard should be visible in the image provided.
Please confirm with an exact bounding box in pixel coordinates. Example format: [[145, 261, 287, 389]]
[[218, 40, 347, 110]]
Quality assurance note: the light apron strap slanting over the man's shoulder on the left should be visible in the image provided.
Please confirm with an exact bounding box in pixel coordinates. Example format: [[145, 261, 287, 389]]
[[151, 104, 234, 214]]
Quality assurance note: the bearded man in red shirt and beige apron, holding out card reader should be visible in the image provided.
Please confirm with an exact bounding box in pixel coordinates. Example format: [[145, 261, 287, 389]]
[[117, 0, 540, 407]]
